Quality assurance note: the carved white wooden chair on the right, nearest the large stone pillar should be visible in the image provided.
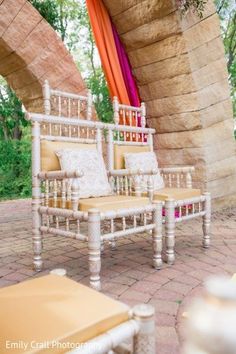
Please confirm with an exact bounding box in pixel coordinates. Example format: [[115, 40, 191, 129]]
[[107, 97, 211, 264]]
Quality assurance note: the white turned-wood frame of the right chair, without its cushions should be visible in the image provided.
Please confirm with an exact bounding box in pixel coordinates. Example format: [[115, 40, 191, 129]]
[[107, 97, 211, 264]]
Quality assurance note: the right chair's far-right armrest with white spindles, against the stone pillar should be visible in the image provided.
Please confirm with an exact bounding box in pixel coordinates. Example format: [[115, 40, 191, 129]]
[[160, 166, 195, 188]]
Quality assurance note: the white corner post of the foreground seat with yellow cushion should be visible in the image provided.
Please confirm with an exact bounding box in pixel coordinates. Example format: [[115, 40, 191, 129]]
[[133, 305, 156, 354]]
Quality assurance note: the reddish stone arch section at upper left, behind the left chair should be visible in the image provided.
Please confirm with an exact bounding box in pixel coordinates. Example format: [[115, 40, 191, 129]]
[[0, 0, 85, 111]]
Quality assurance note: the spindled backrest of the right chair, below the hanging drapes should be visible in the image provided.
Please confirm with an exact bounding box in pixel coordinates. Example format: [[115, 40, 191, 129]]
[[108, 97, 154, 170]]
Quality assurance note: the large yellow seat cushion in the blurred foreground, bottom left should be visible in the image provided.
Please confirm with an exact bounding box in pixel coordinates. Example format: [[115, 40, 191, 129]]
[[0, 275, 129, 354]]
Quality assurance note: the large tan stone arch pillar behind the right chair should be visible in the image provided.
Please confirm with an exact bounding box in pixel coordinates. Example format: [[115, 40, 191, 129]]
[[104, 0, 236, 207]]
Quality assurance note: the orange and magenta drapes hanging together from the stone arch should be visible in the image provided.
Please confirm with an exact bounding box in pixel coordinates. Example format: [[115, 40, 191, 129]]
[[86, 0, 140, 107]]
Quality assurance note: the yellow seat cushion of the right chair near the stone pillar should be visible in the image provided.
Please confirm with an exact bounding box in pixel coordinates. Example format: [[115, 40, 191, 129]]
[[154, 188, 201, 201]]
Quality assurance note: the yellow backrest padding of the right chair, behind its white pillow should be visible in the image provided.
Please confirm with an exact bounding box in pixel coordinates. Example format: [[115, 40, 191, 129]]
[[114, 144, 150, 170]]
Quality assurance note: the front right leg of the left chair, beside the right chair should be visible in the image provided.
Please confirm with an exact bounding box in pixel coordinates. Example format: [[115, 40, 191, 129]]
[[152, 201, 162, 269]]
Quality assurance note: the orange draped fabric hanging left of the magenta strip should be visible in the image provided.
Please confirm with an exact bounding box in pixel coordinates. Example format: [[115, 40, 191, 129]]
[[86, 0, 131, 105]]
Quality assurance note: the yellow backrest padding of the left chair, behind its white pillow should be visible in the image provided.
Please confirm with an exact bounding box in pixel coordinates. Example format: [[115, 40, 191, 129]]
[[41, 140, 96, 171]]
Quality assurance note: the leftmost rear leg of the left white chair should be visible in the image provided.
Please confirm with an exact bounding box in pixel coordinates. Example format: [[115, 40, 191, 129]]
[[32, 199, 43, 272]]
